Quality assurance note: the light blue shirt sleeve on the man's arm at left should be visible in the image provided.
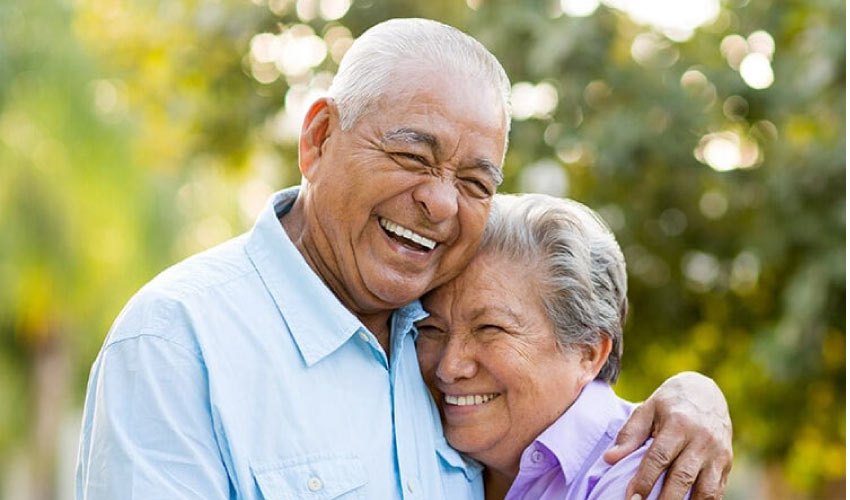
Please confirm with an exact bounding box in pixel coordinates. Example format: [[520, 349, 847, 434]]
[[77, 335, 230, 500]]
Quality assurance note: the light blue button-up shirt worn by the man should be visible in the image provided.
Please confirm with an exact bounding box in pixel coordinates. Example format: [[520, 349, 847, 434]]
[[77, 188, 483, 500]]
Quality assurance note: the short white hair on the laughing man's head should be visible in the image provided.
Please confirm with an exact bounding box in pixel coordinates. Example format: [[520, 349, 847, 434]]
[[328, 19, 511, 147]]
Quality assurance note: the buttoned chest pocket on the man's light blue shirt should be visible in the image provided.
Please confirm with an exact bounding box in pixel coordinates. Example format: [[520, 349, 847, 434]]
[[252, 455, 368, 500]]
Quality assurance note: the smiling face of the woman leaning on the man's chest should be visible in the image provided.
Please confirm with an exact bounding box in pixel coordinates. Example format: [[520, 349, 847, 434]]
[[417, 253, 599, 474]]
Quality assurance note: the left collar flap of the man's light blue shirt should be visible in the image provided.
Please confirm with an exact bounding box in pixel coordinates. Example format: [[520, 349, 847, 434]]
[[246, 187, 365, 366]]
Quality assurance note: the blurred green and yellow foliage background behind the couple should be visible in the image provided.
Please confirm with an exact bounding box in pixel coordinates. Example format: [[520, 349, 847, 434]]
[[0, 0, 846, 500]]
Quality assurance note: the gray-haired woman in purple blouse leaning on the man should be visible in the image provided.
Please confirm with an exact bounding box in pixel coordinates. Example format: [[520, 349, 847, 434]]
[[418, 194, 684, 499]]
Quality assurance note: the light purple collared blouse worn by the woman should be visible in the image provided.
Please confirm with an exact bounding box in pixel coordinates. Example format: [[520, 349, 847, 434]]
[[505, 380, 676, 500]]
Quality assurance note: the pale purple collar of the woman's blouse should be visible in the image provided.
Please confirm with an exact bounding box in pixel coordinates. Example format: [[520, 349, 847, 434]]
[[523, 380, 621, 485]]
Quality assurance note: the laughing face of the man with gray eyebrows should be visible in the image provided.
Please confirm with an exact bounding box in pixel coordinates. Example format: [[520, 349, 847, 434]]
[[309, 69, 506, 313]]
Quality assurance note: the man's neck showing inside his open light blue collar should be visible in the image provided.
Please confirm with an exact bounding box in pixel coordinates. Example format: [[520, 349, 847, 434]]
[[280, 199, 392, 359]]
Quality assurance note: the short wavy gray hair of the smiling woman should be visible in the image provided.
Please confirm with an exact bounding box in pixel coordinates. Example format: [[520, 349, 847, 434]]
[[479, 194, 628, 384]]
